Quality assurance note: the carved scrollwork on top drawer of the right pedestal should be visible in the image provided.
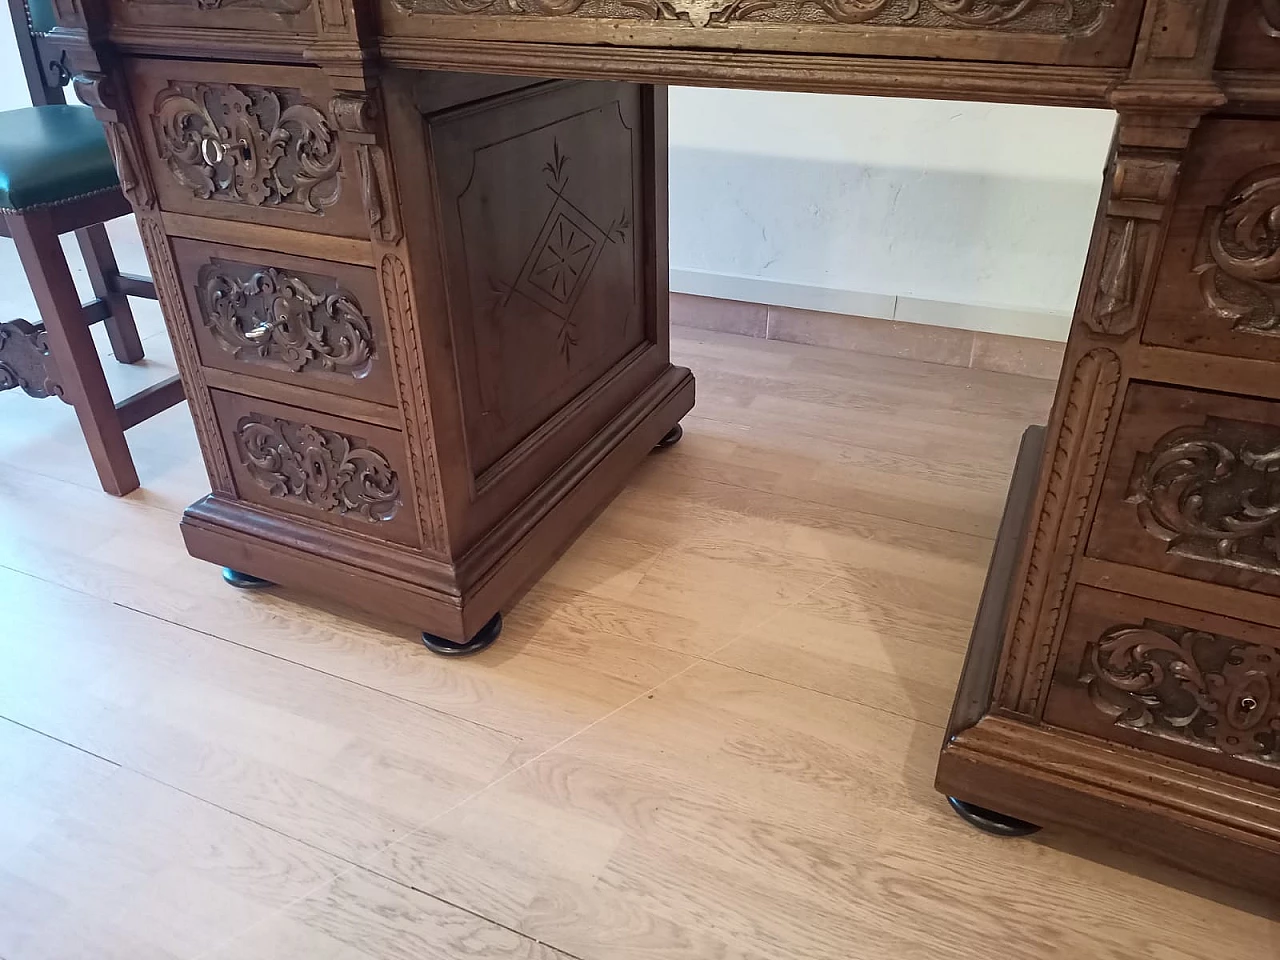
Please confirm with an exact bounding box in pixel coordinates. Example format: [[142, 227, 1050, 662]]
[[1196, 164, 1280, 335]]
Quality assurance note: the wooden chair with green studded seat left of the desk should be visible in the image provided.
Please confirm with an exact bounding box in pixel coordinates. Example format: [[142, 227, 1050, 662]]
[[0, 0, 183, 495]]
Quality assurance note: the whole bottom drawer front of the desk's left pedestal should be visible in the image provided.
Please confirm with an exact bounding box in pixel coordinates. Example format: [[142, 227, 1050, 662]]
[[210, 390, 419, 547]]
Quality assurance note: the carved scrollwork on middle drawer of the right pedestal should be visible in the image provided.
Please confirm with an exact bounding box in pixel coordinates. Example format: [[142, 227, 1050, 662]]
[[1126, 417, 1280, 575]]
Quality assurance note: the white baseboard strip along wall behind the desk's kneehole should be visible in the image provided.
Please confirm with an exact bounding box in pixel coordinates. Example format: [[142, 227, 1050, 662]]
[[671, 268, 1071, 342]]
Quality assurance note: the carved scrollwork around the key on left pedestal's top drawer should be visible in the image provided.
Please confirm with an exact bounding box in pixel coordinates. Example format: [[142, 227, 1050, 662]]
[[154, 83, 342, 214]]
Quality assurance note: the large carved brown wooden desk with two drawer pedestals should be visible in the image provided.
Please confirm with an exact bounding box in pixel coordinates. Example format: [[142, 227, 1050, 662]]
[[58, 0, 1280, 892]]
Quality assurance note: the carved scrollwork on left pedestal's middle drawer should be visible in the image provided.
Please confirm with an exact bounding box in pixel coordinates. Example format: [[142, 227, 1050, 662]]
[[197, 260, 374, 380]]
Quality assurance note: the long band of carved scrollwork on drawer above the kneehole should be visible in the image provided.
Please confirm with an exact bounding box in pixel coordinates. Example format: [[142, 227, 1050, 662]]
[[396, 0, 1107, 36]]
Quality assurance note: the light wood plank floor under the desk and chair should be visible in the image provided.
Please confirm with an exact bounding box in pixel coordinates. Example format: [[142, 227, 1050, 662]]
[[0, 273, 1280, 960]]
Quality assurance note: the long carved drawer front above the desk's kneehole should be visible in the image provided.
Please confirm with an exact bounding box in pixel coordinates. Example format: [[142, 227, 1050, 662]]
[[380, 0, 1141, 67]]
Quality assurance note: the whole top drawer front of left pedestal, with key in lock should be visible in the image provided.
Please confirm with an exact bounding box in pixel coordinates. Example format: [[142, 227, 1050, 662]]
[[129, 60, 370, 238]]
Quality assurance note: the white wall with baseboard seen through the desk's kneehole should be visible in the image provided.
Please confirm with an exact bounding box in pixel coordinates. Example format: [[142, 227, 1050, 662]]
[[671, 88, 1115, 339]]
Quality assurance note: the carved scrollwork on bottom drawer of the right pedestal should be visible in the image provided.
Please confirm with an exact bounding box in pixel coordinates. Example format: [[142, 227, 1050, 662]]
[[1080, 620, 1280, 763]]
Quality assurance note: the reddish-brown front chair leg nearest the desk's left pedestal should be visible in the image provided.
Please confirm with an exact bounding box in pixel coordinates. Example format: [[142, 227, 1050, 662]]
[[5, 210, 138, 497]]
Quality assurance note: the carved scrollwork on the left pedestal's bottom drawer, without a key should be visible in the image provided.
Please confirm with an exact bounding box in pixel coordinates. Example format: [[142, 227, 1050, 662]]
[[236, 415, 401, 524]]
